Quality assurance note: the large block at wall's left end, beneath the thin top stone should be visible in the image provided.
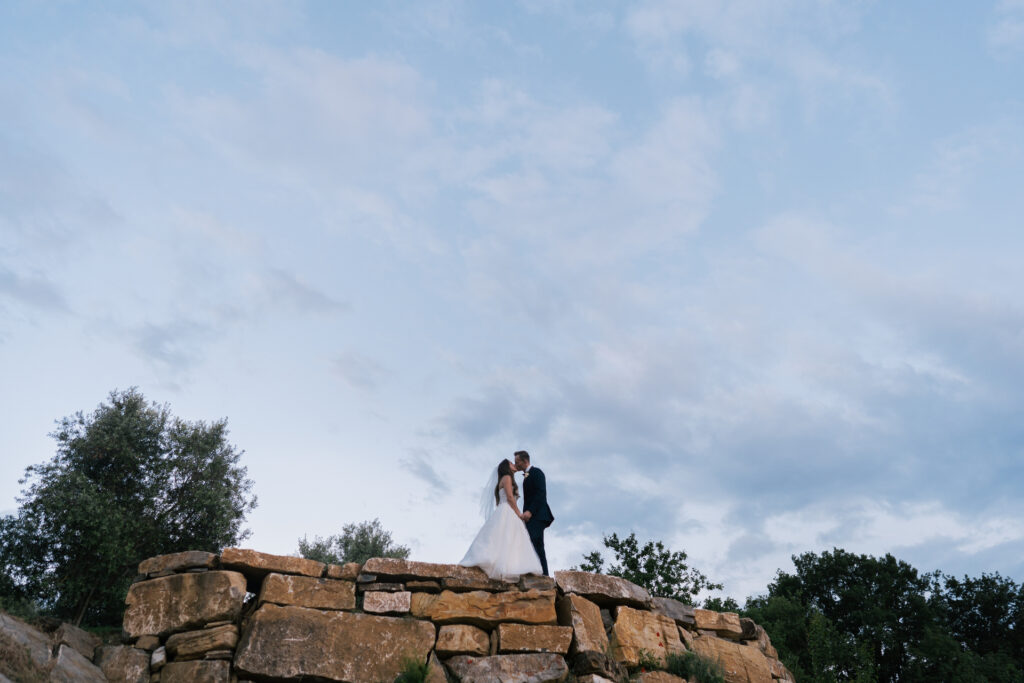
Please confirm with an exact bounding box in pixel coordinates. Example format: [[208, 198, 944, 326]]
[[124, 571, 246, 638]]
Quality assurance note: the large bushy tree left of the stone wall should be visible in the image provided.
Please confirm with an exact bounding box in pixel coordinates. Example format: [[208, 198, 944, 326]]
[[0, 387, 256, 624]]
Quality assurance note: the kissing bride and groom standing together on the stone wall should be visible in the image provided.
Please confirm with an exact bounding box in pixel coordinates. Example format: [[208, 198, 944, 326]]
[[459, 451, 555, 581]]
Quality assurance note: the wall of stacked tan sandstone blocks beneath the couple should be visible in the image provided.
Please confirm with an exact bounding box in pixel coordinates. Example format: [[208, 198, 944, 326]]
[[116, 548, 794, 683]]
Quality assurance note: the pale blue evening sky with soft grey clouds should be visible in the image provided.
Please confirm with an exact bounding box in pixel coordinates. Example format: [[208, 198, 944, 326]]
[[0, 0, 1024, 601]]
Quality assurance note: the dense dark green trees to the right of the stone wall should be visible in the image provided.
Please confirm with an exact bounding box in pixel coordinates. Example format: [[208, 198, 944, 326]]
[[741, 549, 1024, 683]]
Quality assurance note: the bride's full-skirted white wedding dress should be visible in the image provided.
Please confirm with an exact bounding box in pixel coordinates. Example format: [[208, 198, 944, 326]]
[[459, 488, 542, 581]]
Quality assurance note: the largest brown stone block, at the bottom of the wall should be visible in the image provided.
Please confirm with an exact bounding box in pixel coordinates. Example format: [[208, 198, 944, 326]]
[[234, 604, 434, 683]]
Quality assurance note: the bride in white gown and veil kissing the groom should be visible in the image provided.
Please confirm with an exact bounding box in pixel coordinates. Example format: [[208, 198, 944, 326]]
[[459, 460, 542, 581]]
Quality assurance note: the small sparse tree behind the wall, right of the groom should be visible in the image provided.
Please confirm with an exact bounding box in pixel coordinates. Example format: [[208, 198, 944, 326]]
[[580, 533, 722, 604]]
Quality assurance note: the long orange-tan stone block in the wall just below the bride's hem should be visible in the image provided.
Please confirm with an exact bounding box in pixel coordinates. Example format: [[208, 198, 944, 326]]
[[412, 591, 557, 628]]
